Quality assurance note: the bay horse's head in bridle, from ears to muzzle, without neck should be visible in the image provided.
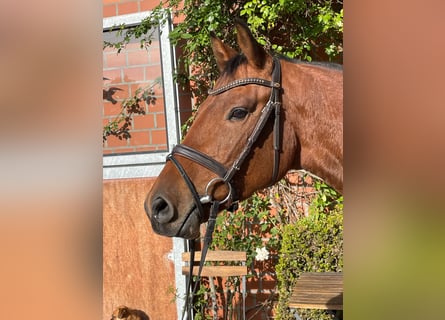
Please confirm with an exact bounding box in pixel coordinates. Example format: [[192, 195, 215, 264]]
[[145, 21, 342, 239]]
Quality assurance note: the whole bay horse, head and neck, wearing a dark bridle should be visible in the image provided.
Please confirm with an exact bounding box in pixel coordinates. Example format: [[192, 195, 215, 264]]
[[144, 21, 343, 239]]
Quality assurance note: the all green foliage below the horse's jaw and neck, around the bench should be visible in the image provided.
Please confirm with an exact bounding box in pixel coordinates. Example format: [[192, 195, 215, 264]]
[[212, 180, 343, 320]]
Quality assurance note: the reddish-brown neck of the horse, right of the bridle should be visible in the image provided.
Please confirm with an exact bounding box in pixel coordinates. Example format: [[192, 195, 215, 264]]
[[282, 61, 343, 192]]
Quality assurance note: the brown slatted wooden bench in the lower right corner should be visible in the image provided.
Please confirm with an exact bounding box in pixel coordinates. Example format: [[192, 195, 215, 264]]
[[289, 272, 343, 310]]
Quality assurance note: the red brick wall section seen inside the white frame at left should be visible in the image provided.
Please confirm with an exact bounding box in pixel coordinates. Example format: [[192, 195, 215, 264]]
[[103, 37, 167, 154]]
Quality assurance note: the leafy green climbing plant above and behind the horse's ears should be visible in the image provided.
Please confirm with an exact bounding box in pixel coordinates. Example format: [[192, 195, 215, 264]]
[[171, 0, 343, 105]]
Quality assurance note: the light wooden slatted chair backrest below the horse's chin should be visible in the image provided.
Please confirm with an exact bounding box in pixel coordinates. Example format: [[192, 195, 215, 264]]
[[182, 250, 247, 277]]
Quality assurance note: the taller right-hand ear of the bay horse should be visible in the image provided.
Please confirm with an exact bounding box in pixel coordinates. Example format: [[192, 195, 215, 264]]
[[235, 19, 268, 69]]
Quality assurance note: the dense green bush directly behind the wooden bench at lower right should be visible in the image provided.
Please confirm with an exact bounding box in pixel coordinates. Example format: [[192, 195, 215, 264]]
[[276, 182, 343, 320]]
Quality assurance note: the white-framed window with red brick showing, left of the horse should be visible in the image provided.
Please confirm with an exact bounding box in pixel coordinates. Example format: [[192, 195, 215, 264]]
[[103, 13, 180, 179]]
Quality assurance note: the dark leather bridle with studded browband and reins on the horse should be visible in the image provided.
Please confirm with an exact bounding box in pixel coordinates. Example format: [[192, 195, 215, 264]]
[[167, 57, 282, 317]]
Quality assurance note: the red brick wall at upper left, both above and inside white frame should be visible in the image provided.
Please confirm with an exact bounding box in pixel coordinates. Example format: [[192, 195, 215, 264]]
[[102, 0, 192, 154]]
